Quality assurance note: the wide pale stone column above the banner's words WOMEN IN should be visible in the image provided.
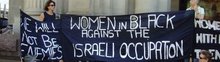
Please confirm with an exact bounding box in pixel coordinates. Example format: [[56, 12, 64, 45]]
[[67, 0, 128, 15]]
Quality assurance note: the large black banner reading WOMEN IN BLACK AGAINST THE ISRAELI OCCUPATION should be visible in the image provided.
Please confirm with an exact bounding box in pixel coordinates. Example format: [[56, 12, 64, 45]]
[[61, 11, 194, 62]]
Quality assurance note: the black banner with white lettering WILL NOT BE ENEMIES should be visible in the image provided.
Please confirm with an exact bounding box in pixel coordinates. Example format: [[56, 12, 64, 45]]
[[20, 11, 62, 61]]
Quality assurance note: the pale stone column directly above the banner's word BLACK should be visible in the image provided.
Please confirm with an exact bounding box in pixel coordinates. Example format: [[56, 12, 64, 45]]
[[135, 0, 171, 13]]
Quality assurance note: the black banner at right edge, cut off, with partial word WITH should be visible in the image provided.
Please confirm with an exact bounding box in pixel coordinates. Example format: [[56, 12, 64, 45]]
[[194, 20, 220, 62]]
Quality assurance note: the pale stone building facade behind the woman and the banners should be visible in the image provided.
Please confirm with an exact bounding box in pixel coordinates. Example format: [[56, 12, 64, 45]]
[[9, 0, 179, 33]]
